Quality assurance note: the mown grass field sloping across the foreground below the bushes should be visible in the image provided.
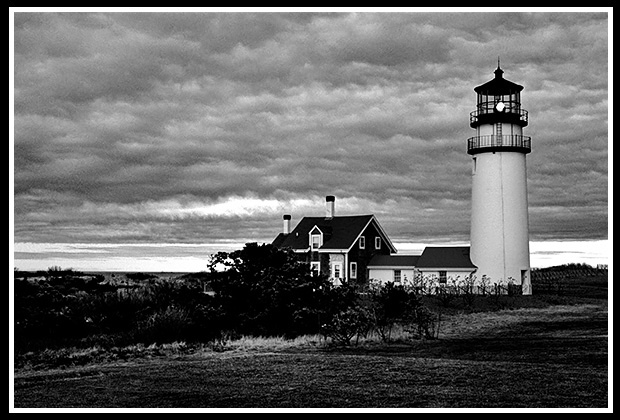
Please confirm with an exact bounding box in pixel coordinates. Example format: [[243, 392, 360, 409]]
[[13, 299, 609, 409]]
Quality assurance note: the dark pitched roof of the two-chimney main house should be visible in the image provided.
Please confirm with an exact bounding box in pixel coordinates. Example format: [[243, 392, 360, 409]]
[[272, 214, 396, 252]]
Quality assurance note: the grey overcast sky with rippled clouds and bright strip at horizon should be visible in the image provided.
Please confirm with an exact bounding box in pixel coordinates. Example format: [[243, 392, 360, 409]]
[[9, 8, 613, 271]]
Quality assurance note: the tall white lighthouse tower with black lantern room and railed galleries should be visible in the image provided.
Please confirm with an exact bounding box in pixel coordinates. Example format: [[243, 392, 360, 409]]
[[467, 60, 531, 294]]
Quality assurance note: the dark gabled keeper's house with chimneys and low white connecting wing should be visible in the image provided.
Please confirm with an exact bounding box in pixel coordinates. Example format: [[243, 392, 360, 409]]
[[273, 195, 476, 284]]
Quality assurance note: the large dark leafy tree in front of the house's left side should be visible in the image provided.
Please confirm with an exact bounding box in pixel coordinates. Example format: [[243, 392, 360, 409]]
[[209, 243, 329, 337]]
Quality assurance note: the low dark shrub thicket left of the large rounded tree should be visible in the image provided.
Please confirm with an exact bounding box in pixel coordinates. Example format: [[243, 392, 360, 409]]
[[14, 276, 217, 353]]
